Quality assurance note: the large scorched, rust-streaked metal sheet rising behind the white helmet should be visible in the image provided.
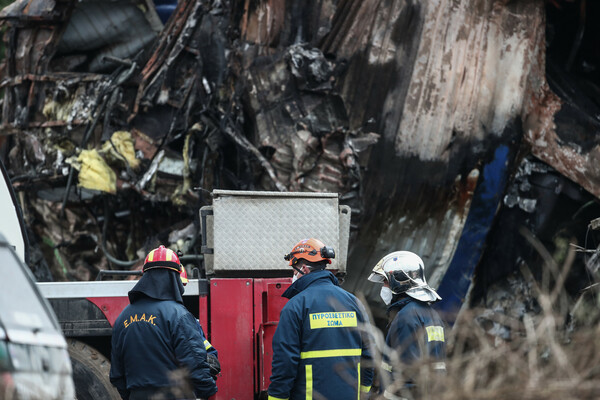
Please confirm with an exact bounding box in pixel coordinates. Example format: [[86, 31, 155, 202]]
[[325, 1, 544, 308]]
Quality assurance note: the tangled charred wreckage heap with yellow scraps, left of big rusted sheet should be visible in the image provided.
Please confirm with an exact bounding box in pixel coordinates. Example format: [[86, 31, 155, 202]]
[[0, 0, 377, 280]]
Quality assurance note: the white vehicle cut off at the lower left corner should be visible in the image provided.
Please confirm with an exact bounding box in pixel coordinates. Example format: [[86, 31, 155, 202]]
[[0, 234, 75, 400]]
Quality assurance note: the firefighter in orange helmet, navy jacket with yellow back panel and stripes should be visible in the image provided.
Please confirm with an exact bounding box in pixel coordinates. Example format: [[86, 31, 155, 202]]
[[268, 239, 373, 400]]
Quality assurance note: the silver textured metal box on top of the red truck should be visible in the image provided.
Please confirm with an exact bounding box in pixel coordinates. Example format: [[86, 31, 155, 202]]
[[206, 190, 350, 272]]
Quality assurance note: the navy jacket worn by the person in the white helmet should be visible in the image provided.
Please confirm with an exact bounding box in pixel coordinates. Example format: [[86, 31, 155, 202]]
[[384, 296, 446, 380]]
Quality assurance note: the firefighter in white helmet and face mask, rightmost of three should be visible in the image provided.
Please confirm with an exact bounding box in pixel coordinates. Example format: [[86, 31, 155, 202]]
[[369, 251, 446, 398]]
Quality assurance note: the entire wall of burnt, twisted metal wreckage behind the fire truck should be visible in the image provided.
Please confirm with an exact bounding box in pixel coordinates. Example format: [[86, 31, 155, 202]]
[[0, 0, 600, 335]]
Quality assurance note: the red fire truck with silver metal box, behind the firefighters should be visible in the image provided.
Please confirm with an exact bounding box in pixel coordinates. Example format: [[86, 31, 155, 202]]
[[38, 190, 350, 400]]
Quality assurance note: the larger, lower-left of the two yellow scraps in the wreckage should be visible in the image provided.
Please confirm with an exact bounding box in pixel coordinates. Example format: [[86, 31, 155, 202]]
[[77, 149, 117, 194]]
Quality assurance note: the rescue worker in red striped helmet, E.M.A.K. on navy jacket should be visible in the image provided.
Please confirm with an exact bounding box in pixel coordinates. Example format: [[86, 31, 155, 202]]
[[110, 246, 217, 400]]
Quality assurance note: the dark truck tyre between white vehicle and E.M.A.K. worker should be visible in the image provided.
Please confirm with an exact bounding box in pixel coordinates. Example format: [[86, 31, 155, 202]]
[[68, 339, 121, 400]]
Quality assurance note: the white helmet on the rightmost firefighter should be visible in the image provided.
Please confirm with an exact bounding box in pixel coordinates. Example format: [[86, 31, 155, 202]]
[[369, 251, 442, 301]]
